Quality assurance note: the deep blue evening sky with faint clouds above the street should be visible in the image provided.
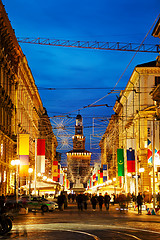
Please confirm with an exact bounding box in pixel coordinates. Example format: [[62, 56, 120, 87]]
[[2, 0, 160, 165]]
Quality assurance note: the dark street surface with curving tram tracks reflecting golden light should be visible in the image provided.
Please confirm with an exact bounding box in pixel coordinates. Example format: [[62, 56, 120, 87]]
[[0, 204, 160, 240]]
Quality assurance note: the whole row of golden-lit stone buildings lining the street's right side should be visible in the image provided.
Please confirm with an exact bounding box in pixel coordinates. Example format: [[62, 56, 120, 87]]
[[100, 18, 160, 195]]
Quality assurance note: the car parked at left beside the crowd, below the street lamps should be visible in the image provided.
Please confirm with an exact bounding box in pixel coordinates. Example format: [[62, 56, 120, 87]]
[[18, 196, 58, 212]]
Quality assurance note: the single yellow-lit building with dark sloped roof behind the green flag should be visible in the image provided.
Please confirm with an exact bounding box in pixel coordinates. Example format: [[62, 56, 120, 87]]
[[114, 57, 160, 196]]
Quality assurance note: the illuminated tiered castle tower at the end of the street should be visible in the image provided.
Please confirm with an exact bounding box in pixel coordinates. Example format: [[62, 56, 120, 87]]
[[67, 114, 91, 191]]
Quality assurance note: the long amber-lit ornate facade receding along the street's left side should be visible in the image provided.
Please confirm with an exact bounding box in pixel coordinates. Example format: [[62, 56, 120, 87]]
[[0, 1, 57, 195]]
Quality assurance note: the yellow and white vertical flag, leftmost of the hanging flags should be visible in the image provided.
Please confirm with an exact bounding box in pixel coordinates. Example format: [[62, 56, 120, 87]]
[[18, 134, 29, 177]]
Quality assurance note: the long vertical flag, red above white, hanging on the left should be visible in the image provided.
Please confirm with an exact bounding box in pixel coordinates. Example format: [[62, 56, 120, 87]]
[[37, 139, 45, 173]]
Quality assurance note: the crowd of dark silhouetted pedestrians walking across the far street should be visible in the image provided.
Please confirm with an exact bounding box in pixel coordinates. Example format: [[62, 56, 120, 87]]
[[0, 189, 160, 214]]
